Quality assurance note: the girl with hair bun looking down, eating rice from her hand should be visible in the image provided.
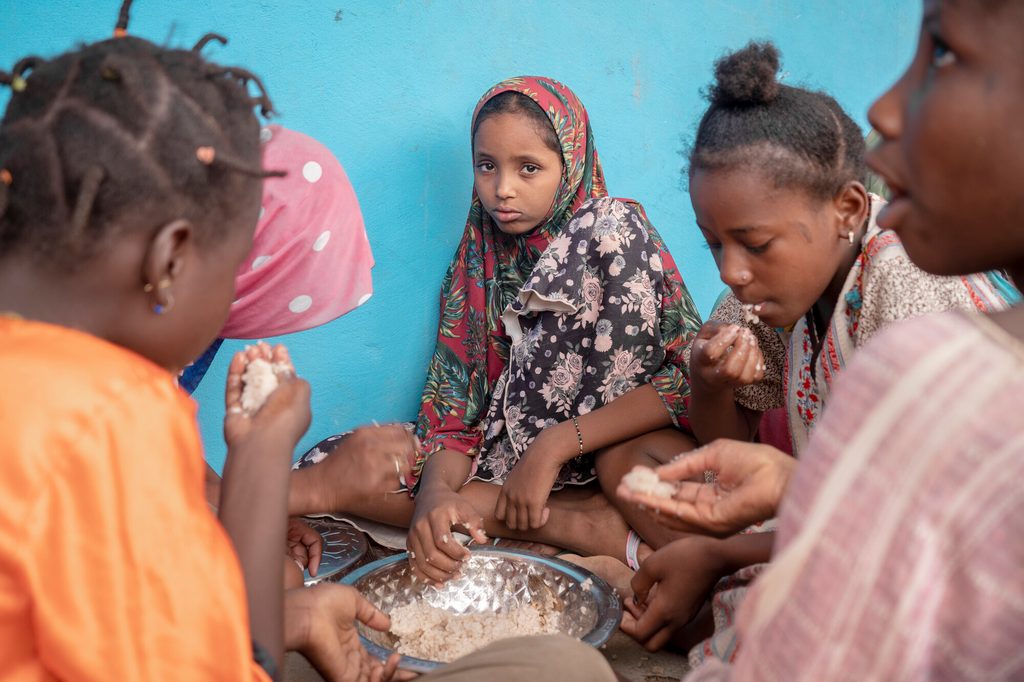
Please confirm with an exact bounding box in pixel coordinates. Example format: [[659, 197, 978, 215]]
[[623, 43, 1016, 664]]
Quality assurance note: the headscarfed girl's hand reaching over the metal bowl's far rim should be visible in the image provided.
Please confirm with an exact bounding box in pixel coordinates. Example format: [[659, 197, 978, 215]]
[[406, 487, 487, 583]]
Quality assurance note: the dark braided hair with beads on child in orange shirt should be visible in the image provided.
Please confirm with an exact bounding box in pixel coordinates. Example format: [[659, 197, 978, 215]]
[[0, 0, 282, 267]]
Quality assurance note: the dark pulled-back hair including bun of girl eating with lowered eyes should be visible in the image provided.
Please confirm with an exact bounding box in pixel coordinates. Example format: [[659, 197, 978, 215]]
[[689, 42, 866, 199]]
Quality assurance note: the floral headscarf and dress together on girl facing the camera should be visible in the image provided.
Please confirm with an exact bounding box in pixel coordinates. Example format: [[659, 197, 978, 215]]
[[416, 77, 700, 484]]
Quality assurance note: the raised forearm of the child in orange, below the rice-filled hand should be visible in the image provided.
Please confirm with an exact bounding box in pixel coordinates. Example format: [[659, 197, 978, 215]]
[[219, 437, 294, 665]]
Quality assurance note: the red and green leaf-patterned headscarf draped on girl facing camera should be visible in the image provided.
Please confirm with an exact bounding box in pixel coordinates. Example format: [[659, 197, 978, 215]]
[[417, 76, 608, 453]]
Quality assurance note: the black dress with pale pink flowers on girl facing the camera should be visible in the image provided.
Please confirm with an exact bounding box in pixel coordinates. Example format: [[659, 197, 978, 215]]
[[473, 197, 699, 488]]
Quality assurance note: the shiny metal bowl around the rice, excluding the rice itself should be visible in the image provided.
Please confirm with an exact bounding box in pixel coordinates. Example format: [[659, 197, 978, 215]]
[[341, 547, 623, 673]]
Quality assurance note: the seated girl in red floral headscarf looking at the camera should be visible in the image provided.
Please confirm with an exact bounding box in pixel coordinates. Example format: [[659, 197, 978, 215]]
[[409, 77, 700, 581]]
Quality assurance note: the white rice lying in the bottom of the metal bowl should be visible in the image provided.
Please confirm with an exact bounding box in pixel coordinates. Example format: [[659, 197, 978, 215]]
[[389, 595, 562, 663]]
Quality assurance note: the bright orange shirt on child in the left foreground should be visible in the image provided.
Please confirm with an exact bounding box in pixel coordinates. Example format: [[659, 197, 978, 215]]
[[0, 317, 267, 682]]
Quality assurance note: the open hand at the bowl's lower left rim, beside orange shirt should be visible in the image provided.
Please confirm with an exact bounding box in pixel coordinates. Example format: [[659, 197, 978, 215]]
[[285, 583, 415, 682]]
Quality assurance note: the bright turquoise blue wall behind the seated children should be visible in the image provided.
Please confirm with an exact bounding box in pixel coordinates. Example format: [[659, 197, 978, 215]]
[[0, 0, 921, 467]]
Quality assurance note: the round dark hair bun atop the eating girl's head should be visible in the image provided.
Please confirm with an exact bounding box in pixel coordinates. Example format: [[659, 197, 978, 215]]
[[709, 42, 779, 106]]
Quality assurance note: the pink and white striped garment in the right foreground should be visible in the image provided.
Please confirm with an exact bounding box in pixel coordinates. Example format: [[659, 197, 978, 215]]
[[687, 313, 1024, 682]]
